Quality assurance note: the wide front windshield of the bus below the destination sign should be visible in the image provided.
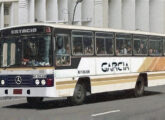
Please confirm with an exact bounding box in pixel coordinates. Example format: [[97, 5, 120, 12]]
[[0, 35, 52, 67]]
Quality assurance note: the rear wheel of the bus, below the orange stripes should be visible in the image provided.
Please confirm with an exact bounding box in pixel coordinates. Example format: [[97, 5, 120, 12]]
[[134, 77, 145, 97]]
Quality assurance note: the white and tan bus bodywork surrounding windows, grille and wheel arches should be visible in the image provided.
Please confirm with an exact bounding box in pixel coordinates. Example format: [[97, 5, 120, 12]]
[[0, 24, 165, 97]]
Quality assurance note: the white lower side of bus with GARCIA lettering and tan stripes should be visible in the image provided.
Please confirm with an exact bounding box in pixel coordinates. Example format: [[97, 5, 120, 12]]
[[56, 57, 165, 96]]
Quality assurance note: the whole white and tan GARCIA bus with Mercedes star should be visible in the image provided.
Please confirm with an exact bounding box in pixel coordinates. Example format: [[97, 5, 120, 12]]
[[0, 23, 165, 104]]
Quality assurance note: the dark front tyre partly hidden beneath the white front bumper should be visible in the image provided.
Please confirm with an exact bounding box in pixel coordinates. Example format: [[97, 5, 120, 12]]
[[27, 97, 43, 105]]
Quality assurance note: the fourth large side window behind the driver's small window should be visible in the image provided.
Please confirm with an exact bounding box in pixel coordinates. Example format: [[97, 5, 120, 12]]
[[133, 35, 148, 55]]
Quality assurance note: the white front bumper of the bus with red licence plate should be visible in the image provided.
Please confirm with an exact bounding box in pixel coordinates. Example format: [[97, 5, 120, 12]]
[[0, 87, 57, 97]]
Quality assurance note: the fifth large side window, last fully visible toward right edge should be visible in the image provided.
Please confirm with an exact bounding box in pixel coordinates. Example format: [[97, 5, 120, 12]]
[[148, 37, 162, 55]]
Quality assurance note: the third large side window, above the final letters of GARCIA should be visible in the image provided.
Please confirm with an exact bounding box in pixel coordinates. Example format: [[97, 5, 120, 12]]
[[116, 34, 132, 55]]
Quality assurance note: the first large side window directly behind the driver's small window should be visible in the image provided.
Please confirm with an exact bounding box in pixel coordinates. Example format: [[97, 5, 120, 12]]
[[72, 31, 94, 55]]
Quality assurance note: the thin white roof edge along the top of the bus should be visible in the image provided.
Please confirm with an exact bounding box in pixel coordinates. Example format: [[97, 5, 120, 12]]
[[1, 23, 165, 37]]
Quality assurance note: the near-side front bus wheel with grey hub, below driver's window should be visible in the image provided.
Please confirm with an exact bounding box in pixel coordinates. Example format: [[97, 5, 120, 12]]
[[70, 83, 86, 105]]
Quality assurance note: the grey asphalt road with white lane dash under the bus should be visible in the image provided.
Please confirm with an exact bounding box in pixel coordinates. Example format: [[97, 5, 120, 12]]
[[0, 86, 165, 120]]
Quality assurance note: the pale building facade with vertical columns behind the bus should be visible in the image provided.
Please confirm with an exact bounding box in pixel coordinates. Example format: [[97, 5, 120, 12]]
[[0, 0, 165, 33]]
